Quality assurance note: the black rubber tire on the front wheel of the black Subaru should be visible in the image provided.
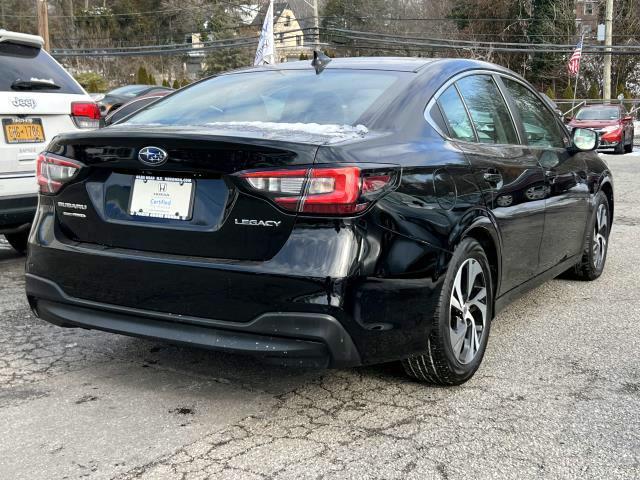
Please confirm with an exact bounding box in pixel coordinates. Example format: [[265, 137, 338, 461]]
[[572, 191, 612, 281]]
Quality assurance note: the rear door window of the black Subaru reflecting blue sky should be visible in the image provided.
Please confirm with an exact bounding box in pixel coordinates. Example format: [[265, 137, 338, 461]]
[[457, 75, 518, 144]]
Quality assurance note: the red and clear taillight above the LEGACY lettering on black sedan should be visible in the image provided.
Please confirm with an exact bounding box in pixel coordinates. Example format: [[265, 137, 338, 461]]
[[240, 167, 399, 215]]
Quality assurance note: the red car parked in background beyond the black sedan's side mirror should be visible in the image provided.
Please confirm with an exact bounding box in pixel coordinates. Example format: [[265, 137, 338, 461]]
[[569, 105, 635, 153]]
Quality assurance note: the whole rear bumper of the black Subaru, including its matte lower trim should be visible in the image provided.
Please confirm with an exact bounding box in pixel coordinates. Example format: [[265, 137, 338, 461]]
[[26, 199, 448, 366]]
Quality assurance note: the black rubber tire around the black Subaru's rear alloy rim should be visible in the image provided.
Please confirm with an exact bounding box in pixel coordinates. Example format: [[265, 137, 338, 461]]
[[402, 238, 493, 386]]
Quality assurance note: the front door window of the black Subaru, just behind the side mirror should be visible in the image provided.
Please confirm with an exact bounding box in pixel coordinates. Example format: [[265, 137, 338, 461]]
[[502, 78, 564, 148]]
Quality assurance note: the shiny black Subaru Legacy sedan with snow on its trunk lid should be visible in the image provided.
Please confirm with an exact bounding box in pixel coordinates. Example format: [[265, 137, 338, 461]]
[[26, 58, 614, 385]]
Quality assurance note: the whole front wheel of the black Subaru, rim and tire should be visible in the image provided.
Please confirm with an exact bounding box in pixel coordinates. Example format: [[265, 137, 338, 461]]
[[573, 192, 611, 280]]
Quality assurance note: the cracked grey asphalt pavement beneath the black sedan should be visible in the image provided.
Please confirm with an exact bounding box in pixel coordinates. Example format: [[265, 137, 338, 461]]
[[0, 154, 640, 480]]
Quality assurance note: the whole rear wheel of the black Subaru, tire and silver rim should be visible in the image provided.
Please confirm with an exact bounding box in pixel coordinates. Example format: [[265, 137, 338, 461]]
[[402, 238, 493, 385]]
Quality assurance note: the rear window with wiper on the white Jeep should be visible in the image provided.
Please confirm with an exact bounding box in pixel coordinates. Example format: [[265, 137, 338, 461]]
[[0, 42, 84, 94]]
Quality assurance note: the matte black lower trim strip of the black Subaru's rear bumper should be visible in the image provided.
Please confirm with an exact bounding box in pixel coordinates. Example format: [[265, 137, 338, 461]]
[[26, 274, 361, 367]]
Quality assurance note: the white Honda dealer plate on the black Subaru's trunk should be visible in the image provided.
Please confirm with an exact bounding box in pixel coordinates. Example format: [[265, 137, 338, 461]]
[[129, 175, 194, 220]]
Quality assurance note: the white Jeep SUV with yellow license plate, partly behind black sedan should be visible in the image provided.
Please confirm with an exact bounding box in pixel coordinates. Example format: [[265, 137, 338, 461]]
[[0, 30, 100, 251]]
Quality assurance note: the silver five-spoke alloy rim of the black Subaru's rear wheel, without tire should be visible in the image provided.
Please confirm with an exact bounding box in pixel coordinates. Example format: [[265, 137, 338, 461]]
[[449, 258, 487, 364]]
